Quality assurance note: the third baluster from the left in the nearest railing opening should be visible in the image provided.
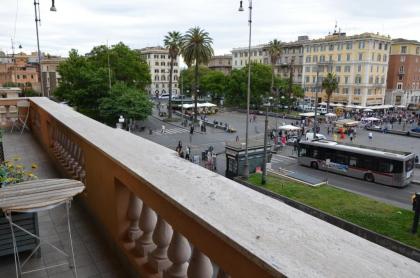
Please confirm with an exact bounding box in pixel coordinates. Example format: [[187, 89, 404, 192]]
[[149, 215, 173, 272]]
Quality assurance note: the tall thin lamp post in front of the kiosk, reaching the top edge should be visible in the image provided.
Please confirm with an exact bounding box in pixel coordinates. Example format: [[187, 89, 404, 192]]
[[239, 0, 252, 178]]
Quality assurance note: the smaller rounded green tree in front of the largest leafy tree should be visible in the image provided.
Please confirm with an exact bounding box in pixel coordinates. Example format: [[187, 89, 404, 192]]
[[99, 81, 153, 125]]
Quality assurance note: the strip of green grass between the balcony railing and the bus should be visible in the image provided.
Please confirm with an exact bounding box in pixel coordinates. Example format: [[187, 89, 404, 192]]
[[249, 174, 420, 248]]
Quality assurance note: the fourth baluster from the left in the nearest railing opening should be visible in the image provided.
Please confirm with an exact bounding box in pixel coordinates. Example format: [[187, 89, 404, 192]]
[[163, 231, 191, 278]]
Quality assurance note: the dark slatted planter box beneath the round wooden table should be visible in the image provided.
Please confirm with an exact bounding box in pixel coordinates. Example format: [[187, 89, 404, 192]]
[[0, 212, 39, 256]]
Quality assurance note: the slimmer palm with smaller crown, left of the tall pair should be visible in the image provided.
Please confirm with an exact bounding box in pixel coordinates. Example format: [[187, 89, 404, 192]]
[[163, 31, 182, 119]]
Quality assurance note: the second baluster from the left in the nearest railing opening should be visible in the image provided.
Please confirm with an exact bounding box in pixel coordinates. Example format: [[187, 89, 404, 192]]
[[136, 203, 157, 257]]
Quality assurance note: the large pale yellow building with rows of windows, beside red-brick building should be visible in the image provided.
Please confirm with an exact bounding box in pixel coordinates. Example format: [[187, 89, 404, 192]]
[[302, 32, 391, 106]]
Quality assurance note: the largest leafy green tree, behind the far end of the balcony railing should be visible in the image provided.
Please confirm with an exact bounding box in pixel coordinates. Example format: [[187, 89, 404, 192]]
[[54, 43, 151, 122]]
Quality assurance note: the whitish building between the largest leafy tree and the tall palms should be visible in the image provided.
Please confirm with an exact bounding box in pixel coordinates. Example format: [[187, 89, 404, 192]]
[[138, 46, 180, 97]]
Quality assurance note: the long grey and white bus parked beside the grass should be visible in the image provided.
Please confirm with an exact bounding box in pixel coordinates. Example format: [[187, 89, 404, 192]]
[[298, 140, 415, 187]]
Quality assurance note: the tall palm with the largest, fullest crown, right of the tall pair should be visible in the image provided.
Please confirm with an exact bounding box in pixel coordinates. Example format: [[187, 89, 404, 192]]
[[182, 27, 214, 121]]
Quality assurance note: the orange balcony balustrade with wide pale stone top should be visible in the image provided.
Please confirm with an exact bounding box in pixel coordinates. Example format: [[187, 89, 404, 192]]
[[0, 98, 420, 277]]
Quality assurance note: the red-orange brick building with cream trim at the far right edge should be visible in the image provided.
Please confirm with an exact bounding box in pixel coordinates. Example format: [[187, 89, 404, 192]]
[[385, 39, 420, 107]]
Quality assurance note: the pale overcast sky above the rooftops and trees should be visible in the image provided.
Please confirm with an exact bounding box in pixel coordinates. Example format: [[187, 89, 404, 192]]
[[0, 0, 420, 56]]
